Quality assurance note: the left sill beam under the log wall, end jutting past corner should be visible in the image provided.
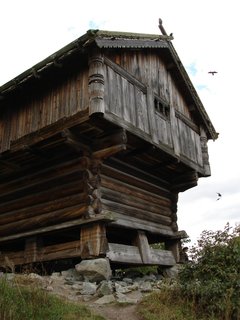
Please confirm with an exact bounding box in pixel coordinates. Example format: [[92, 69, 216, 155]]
[[0, 210, 115, 243]]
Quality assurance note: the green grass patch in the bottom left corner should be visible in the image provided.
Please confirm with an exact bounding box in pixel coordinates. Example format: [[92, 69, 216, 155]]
[[0, 277, 104, 320]]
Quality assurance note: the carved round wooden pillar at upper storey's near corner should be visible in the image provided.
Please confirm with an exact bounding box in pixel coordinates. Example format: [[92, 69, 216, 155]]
[[88, 51, 104, 115]]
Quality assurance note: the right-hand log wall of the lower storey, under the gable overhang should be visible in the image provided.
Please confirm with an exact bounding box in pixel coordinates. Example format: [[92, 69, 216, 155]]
[[101, 161, 176, 235]]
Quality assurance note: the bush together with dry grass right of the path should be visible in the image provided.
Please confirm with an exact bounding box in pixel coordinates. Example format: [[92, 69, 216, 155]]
[[139, 224, 240, 320]]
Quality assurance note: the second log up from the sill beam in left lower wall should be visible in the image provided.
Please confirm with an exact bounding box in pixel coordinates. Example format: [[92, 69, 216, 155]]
[[0, 193, 90, 225]]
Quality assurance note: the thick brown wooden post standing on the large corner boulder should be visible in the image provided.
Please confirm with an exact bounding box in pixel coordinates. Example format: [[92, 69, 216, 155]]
[[80, 223, 107, 259]]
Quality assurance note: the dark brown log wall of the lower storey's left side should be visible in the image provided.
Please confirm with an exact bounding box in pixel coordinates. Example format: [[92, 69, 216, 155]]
[[0, 157, 93, 240]]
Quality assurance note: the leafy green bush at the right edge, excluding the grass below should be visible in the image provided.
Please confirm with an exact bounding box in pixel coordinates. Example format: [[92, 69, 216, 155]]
[[179, 224, 240, 320]]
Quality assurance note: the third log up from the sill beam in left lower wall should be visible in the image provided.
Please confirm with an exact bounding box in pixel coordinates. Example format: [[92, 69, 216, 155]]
[[0, 179, 84, 214]]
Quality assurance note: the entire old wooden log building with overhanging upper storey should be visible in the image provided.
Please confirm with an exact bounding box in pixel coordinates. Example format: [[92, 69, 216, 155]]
[[0, 25, 218, 268]]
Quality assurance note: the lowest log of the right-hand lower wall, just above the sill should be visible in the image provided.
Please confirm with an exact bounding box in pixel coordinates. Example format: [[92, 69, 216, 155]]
[[102, 199, 172, 226]]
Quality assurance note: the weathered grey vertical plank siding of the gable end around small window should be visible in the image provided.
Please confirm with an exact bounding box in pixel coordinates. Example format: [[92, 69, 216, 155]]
[[104, 52, 203, 168]]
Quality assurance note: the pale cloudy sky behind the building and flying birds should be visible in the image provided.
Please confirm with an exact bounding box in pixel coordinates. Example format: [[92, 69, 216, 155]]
[[0, 0, 240, 244]]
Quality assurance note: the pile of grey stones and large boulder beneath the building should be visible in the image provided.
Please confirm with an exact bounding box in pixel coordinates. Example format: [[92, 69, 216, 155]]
[[1, 259, 178, 305]]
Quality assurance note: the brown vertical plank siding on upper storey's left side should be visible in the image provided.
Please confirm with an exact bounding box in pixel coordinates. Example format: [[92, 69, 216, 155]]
[[0, 68, 88, 152]]
